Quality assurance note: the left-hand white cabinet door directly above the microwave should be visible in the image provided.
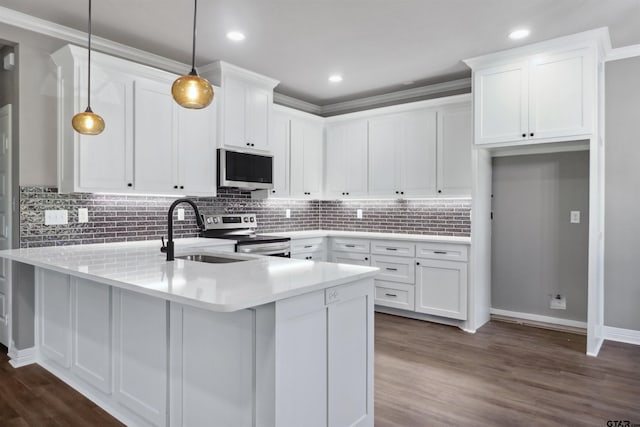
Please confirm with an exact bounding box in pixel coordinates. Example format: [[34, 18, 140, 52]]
[[219, 77, 249, 148]]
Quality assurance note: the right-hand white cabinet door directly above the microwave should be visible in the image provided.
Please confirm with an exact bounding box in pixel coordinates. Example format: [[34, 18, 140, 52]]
[[245, 86, 272, 151]]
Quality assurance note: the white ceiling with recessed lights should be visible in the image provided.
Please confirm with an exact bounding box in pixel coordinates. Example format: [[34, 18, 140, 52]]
[[0, 0, 640, 105]]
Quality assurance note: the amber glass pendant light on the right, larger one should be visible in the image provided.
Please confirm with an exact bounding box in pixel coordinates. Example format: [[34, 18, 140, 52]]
[[171, 0, 213, 109]]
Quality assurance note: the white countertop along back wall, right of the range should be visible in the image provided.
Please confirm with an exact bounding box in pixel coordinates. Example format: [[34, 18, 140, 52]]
[[260, 230, 471, 245]]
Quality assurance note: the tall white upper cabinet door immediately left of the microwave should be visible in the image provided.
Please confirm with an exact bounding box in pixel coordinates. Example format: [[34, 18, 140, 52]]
[[174, 100, 217, 197]]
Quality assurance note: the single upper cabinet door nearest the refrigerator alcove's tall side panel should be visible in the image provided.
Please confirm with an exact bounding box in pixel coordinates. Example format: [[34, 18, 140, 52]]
[[437, 105, 473, 196]]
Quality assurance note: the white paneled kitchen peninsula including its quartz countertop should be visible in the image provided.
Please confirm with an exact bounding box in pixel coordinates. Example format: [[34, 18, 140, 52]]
[[0, 239, 377, 427]]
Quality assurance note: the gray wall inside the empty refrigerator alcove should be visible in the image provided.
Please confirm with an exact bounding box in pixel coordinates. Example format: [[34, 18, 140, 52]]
[[491, 152, 589, 321]]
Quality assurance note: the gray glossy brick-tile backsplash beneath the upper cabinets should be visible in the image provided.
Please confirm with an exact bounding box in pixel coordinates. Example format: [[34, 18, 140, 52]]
[[20, 187, 471, 247]]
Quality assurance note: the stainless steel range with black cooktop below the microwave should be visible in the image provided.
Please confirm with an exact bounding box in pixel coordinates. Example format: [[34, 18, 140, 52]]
[[202, 214, 291, 258]]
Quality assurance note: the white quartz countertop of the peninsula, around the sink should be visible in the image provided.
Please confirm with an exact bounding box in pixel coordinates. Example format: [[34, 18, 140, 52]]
[[0, 238, 378, 312]]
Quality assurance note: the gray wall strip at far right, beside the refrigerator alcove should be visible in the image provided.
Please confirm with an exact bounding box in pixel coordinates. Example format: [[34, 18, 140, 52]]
[[604, 58, 640, 330]]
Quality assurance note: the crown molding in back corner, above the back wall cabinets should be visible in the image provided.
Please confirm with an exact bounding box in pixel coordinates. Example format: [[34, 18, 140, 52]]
[[273, 78, 471, 117]]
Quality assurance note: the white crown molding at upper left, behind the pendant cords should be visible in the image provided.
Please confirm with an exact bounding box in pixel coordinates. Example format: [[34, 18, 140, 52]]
[[0, 6, 191, 74]]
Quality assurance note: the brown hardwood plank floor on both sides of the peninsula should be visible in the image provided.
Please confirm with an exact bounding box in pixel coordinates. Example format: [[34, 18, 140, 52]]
[[0, 314, 640, 427]]
